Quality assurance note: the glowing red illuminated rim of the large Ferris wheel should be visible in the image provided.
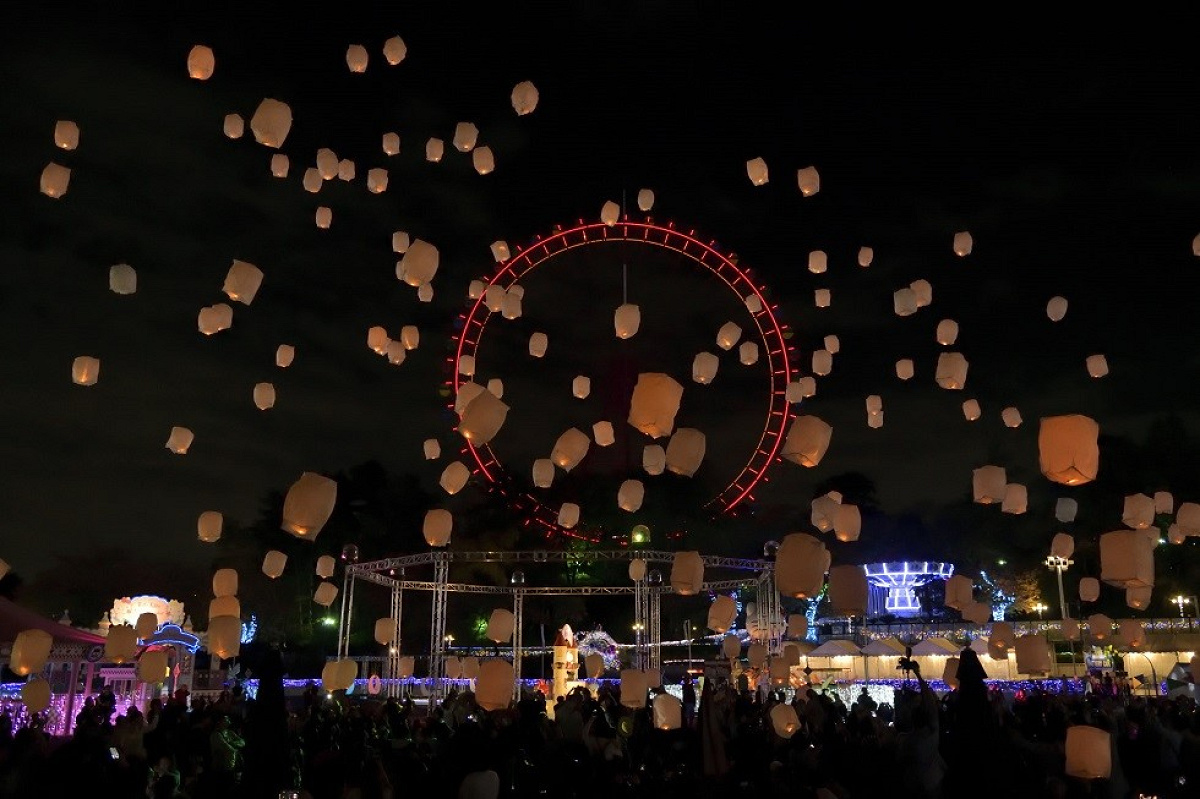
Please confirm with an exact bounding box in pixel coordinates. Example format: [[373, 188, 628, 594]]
[[446, 220, 792, 539]]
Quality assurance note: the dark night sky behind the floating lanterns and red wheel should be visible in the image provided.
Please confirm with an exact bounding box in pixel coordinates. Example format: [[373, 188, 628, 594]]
[[7, 2, 1200, 609]]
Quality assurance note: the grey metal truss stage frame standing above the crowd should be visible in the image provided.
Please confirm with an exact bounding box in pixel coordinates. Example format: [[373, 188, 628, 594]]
[[337, 549, 781, 697]]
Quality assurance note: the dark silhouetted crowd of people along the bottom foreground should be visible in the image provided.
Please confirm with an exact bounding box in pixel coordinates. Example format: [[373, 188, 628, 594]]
[[0, 650, 1200, 799]]
